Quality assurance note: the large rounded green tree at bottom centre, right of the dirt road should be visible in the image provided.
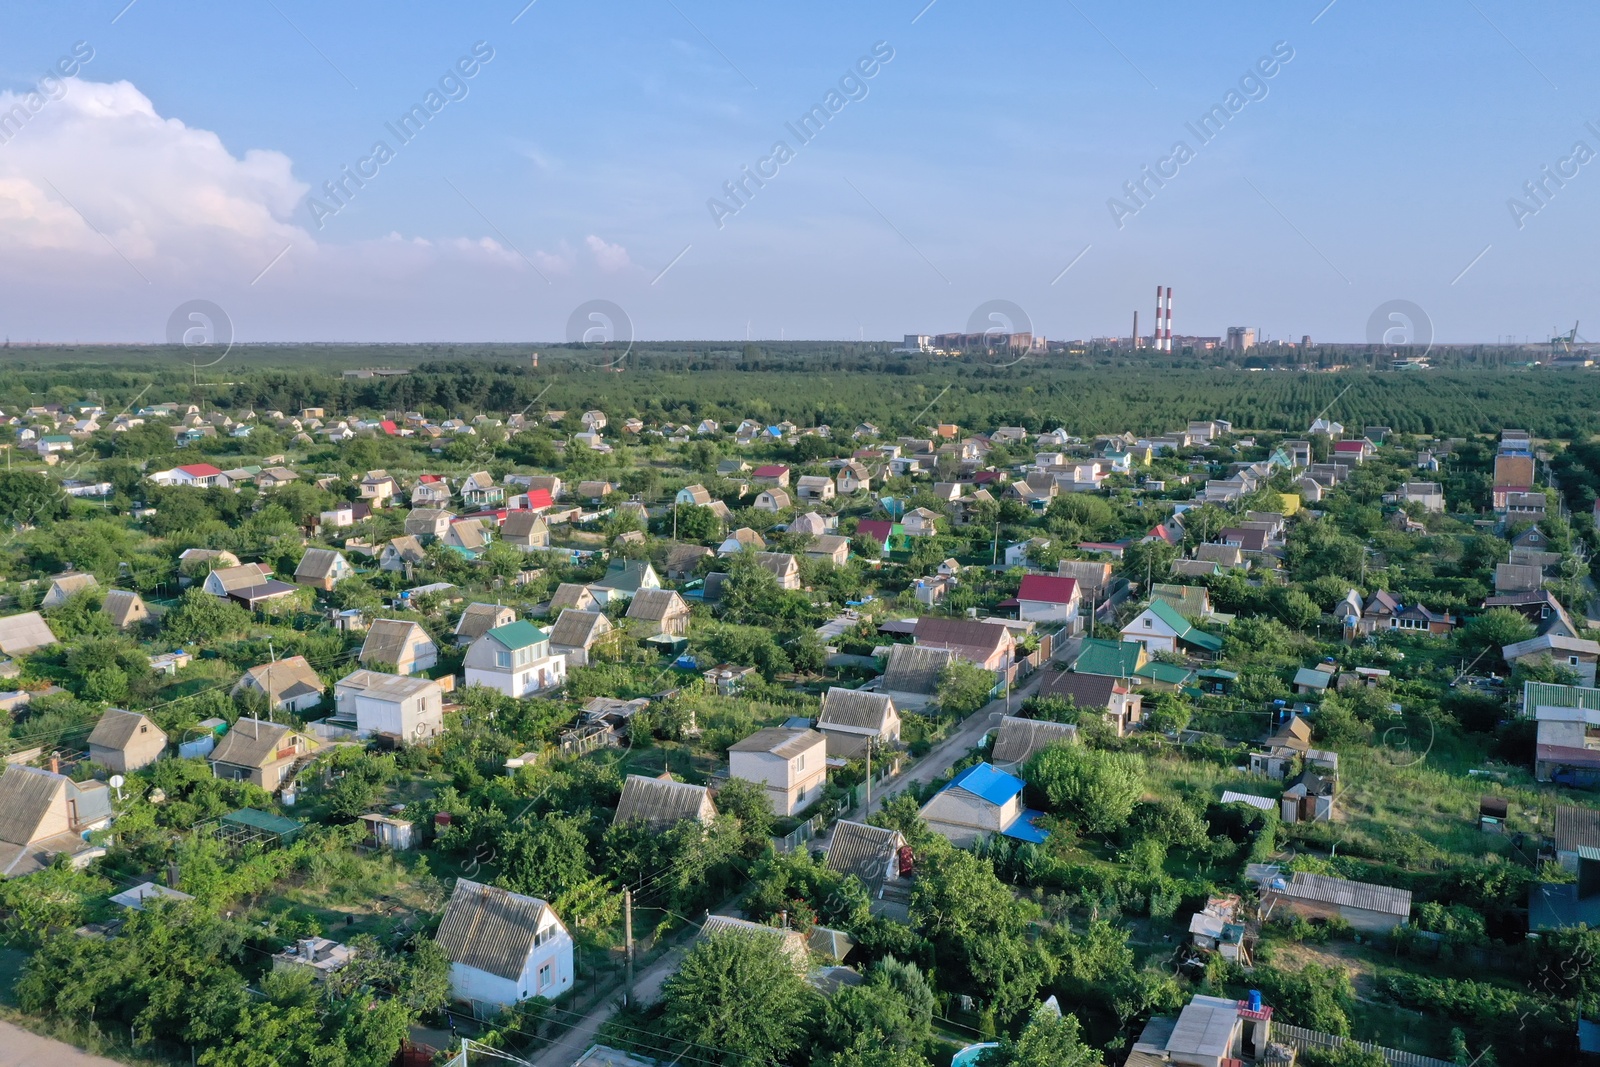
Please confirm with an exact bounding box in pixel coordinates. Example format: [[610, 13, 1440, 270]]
[[661, 931, 814, 1067]]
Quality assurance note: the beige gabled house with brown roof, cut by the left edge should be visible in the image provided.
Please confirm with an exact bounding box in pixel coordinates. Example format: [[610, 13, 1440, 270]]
[[0, 766, 114, 878]]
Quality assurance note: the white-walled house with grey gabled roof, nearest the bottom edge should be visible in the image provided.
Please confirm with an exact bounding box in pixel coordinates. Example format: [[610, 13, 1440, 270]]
[[434, 878, 573, 1008]]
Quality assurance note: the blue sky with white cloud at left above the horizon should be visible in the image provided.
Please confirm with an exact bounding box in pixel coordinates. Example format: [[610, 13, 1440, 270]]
[[0, 0, 1600, 341]]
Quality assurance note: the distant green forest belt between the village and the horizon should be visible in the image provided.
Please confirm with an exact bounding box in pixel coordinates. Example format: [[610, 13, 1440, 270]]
[[0, 344, 1600, 440]]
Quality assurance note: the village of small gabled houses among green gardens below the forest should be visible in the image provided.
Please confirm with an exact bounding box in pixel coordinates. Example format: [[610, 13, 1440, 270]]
[[0, 402, 1600, 1067]]
